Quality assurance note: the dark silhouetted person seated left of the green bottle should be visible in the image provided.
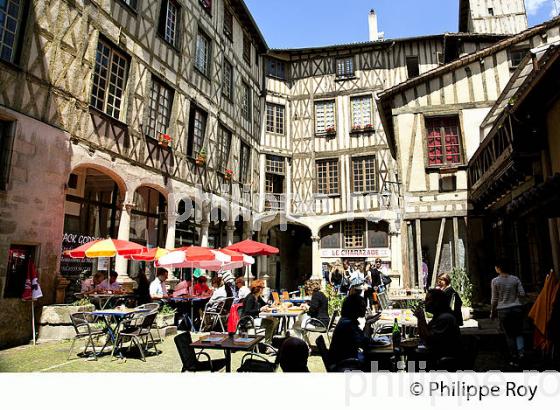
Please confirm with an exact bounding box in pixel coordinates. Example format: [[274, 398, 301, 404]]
[[329, 294, 371, 364]]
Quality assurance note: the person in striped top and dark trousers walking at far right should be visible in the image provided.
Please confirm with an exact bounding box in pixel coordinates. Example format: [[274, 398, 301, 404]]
[[490, 260, 525, 365]]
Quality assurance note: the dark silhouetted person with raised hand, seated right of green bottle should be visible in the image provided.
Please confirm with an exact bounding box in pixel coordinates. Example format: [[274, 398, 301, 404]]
[[414, 289, 462, 361]]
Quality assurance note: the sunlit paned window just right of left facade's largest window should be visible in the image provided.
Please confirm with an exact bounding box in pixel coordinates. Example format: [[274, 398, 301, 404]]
[[146, 77, 173, 139]]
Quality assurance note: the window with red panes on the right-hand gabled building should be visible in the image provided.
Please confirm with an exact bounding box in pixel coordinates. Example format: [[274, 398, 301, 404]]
[[426, 117, 462, 166]]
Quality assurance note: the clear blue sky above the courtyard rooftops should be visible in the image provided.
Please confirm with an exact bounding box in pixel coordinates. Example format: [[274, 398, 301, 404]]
[[245, 0, 560, 48]]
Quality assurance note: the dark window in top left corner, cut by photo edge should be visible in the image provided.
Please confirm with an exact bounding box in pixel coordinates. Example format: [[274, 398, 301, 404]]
[[0, 0, 24, 63]]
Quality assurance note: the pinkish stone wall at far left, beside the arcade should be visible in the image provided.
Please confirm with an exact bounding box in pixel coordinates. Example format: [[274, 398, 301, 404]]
[[0, 108, 71, 348]]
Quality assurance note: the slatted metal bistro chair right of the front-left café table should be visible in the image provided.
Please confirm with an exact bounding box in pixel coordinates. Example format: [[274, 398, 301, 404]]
[[111, 311, 160, 362]]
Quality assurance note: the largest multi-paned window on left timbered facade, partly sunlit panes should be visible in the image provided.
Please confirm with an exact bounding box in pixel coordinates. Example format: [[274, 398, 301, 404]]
[[91, 38, 128, 119]]
